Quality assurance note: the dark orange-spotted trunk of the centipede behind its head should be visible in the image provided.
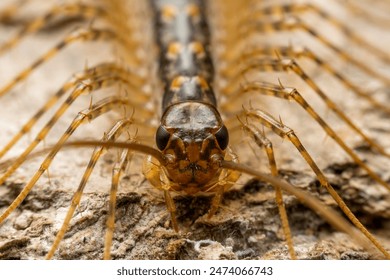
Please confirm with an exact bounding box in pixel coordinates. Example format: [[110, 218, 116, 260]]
[[152, 0, 216, 111]]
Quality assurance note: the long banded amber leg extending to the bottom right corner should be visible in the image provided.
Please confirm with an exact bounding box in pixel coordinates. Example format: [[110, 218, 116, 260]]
[[243, 106, 390, 258]]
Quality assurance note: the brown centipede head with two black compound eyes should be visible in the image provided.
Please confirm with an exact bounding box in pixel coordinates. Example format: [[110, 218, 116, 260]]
[[156, 102, 229, 193]]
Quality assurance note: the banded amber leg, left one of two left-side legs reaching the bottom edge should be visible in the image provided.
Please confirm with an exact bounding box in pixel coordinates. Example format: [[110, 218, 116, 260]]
[[46, 117, 132, 259]]
